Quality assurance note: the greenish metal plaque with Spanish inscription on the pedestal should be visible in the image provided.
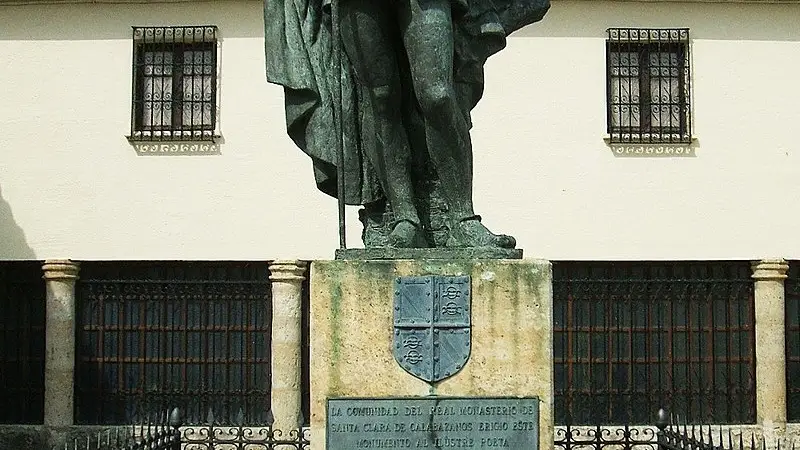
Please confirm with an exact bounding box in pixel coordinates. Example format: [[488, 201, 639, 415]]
[[326, 397, 539, 450]]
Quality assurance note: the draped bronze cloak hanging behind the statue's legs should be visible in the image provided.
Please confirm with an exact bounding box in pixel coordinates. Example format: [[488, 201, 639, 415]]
[[264, 0, 550, 205]]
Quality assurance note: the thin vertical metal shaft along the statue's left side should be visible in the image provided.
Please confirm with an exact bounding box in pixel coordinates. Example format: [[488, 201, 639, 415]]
[[331, 0, 347, 248]]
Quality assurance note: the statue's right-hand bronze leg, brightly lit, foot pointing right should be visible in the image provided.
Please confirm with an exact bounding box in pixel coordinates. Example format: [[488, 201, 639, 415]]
[[399, 0, 516, 248]]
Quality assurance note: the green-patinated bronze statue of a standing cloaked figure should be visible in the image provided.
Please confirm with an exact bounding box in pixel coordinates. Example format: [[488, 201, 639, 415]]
[[264, 0, 549, 249]]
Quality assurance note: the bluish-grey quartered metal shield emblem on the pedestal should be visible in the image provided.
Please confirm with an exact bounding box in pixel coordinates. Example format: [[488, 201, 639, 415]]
[[393, 275, 471, 383]]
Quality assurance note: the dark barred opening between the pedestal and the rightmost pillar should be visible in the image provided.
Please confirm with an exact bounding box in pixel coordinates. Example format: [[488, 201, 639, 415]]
[[553, 261, 755, 425]]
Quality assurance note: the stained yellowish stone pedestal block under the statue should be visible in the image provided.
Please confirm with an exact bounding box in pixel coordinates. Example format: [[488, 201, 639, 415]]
[[311, 260, 553, 450]]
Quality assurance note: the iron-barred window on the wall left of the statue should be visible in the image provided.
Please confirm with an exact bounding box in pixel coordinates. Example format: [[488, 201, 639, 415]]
[[129, 25, 217, 141]]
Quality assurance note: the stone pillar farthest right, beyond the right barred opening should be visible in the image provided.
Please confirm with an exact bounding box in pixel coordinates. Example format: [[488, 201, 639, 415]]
[[752, 259, 789, 434]]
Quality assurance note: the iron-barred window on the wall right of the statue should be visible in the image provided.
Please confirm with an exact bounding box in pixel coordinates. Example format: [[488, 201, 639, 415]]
[[606, 28, 692, 143]]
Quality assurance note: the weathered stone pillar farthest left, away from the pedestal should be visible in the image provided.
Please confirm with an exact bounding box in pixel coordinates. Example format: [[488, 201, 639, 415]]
[[42, 259, 79, 426]]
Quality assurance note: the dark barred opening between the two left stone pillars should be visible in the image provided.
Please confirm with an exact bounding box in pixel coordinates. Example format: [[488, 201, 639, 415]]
[[75, 261, 272, 425]]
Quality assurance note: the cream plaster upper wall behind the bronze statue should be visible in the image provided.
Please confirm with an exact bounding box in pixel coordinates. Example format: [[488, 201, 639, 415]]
[[0, 0, 800, 260]]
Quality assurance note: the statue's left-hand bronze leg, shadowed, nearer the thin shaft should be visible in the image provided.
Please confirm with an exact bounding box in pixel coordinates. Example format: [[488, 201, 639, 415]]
[[340, 0, 425, 247]]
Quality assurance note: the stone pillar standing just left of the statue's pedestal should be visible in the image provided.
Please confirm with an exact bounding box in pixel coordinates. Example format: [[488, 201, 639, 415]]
[[269, 260, 306, 436]]
